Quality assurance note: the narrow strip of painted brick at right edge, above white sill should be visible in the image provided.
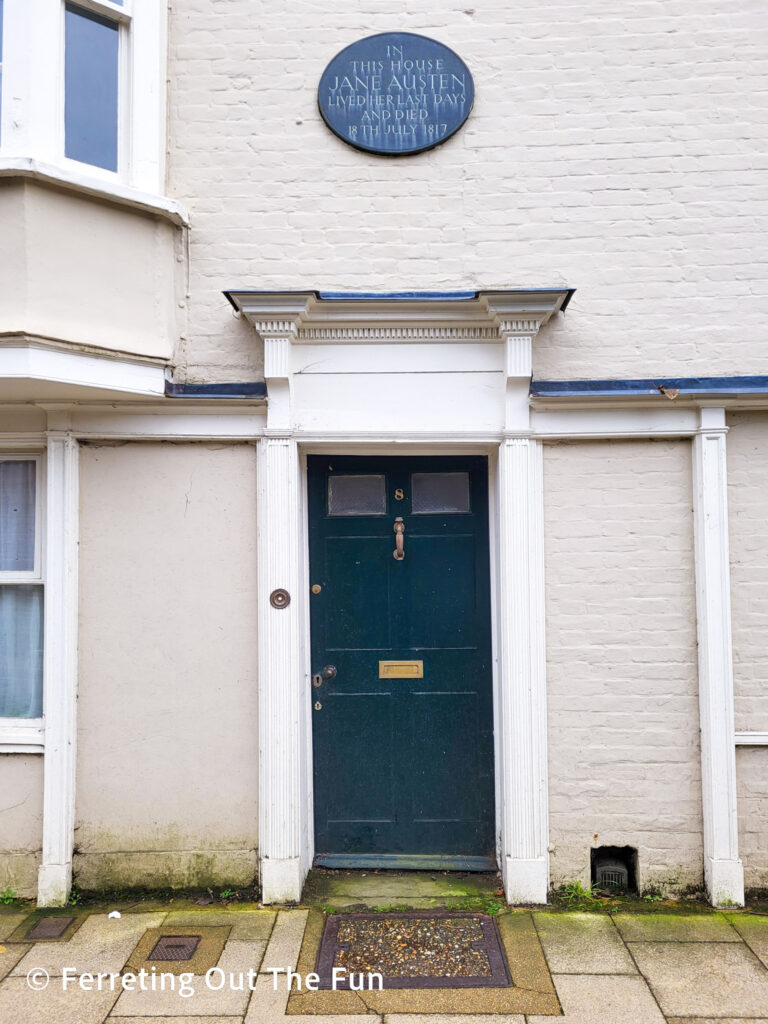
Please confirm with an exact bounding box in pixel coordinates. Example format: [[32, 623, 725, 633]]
[[727, 413, 768, 733]]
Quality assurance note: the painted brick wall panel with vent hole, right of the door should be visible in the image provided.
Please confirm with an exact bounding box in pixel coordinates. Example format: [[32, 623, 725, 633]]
[[544, 441, 702, 892]]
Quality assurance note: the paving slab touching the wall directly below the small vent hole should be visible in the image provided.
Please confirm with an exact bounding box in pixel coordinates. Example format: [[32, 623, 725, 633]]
[[534, 912, 637, 974]]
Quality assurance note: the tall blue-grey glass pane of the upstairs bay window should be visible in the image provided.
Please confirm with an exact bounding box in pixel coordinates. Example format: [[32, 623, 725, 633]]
[[65, 4, 119, 171]]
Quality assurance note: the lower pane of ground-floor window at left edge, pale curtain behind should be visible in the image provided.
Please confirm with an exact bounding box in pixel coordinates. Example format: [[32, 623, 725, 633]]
[[0, 586, 43, 718]]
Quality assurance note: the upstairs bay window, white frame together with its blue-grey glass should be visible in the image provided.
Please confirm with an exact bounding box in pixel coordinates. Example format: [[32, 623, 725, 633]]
[[0, 0, 167, 196]]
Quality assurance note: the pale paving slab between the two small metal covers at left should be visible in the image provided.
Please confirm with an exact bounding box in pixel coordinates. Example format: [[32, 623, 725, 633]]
[[11, 912, 165, 977]]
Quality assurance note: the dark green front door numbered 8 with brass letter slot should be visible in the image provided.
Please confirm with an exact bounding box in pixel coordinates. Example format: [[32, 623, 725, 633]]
[[308, 456, 496, 868]]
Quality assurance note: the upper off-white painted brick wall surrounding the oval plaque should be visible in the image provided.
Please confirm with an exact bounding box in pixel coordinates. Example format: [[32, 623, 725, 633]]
[[169, 0, 768, 379]]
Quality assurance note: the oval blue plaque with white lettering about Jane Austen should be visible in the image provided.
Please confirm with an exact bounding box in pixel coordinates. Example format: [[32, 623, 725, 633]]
[[317, 32, 475, 157]]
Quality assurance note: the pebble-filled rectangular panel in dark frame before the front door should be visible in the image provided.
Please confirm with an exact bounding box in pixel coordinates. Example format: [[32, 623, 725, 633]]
[[315, 911, 512, 991]]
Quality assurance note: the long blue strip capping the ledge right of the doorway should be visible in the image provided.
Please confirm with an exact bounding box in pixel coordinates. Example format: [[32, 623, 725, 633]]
[[530, 377, 768, 398]]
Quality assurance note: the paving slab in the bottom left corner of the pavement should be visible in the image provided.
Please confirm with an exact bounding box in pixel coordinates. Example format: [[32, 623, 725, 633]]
[[0, 978, 117, 1024]]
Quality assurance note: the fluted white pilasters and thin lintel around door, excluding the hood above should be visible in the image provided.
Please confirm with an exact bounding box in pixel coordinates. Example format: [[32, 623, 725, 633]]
[[258, 438, 549, 903]]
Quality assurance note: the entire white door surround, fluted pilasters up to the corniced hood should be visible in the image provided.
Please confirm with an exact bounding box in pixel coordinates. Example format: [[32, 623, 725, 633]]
[[234, 290, 567, 903]]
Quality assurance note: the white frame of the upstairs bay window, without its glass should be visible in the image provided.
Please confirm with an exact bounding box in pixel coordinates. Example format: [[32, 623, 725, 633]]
[[0, 0, 168, 196]]
